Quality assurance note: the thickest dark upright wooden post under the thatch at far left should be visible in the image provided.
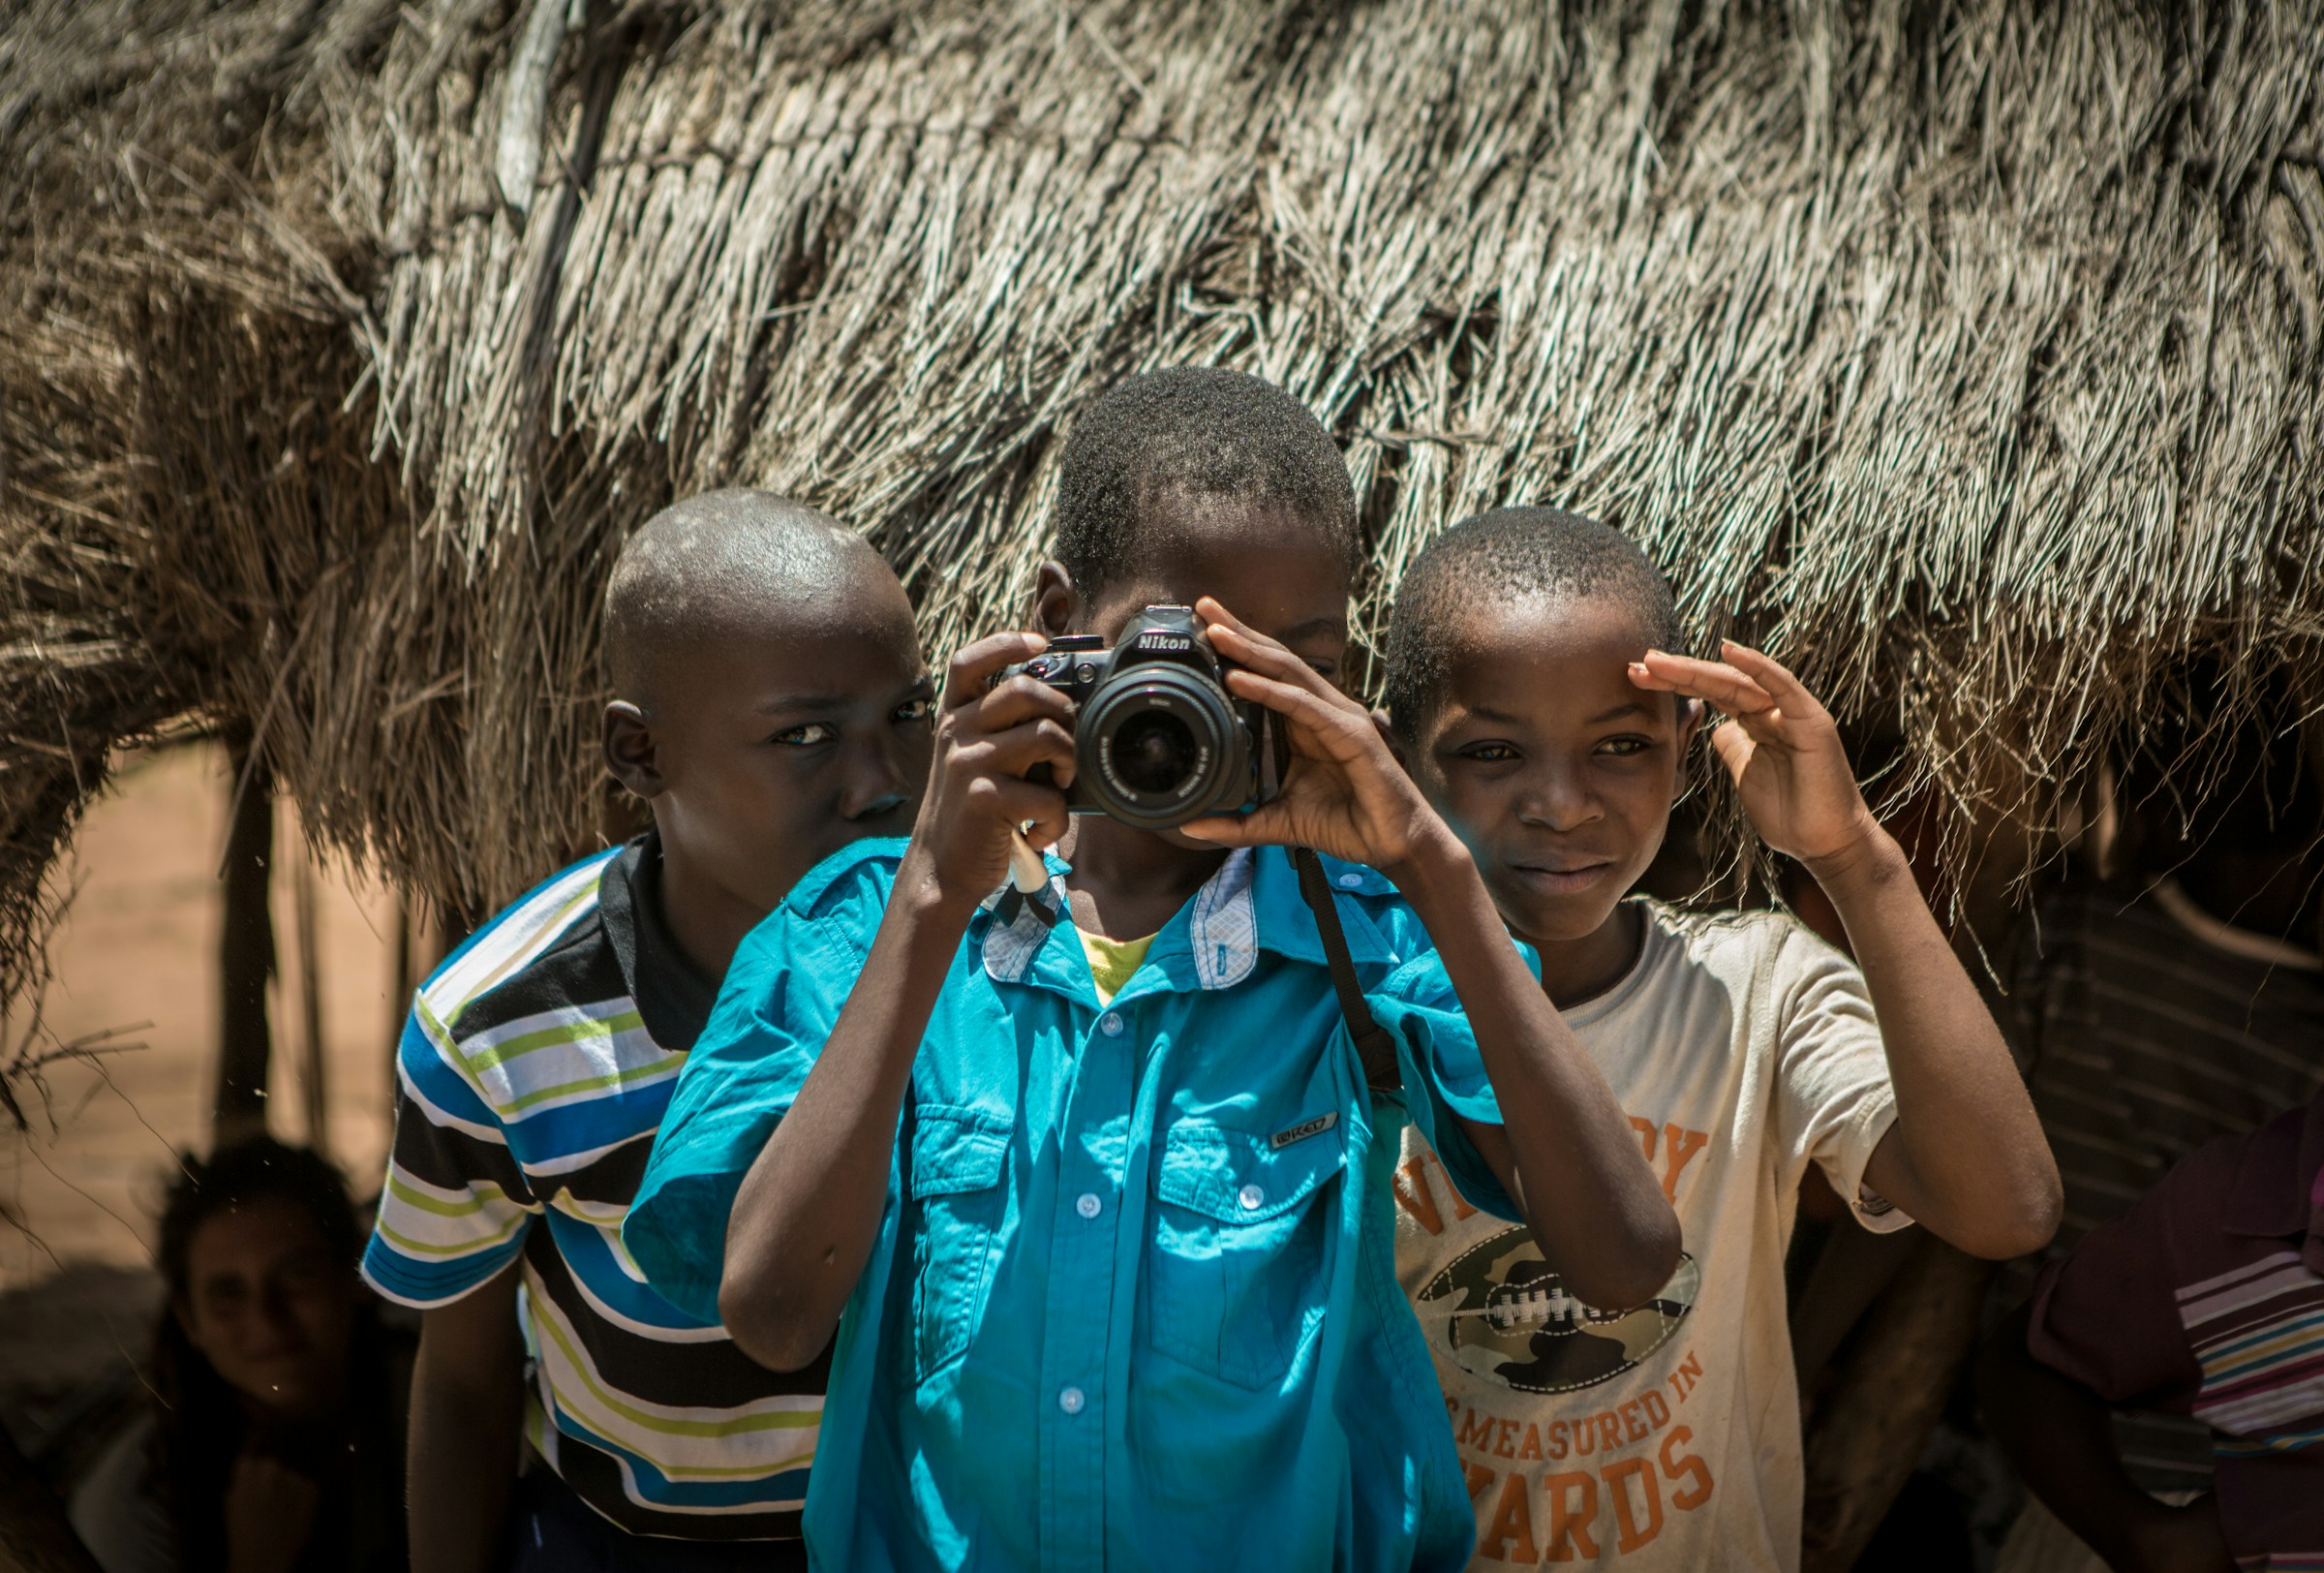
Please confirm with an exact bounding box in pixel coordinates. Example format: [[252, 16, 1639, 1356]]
[[211, 734, 274, 1148]]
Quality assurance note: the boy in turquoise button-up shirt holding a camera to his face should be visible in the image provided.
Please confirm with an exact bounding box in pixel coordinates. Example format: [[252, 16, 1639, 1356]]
[[623, 369, 1675, 1568]]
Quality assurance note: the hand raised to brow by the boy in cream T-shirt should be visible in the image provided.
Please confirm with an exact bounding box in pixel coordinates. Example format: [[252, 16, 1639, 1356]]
[[1629, 639, 1881, 872]]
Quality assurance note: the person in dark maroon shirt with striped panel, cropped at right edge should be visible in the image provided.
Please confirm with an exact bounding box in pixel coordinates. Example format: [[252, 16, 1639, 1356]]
[[1980, 1096, 2324, 1573]]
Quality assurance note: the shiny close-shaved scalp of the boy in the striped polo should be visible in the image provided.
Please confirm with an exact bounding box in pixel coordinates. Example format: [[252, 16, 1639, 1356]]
[[604, 488, 908, 709]]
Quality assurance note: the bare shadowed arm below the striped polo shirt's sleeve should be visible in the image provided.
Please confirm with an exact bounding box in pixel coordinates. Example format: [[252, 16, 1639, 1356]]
[[405, 1266, 525, 1573]]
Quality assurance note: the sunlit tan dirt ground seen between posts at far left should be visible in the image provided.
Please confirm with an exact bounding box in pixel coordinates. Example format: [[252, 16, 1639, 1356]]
[[0, 746, 400, 1422]]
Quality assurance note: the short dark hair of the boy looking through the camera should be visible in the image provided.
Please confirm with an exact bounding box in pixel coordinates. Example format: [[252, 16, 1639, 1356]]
[[1055, 367, 1358, 597]]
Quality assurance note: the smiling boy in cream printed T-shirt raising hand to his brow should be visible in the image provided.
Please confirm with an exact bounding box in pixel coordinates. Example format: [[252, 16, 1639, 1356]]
[[1388, 509, 2059, 1573]]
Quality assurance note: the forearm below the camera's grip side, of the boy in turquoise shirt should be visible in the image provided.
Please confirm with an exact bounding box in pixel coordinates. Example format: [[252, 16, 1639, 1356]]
[[719, 855, 974, 1371]]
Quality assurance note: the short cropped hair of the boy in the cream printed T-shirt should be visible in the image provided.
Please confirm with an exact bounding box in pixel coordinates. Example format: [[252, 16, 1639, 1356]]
[[1383, 509, 1685, 739]]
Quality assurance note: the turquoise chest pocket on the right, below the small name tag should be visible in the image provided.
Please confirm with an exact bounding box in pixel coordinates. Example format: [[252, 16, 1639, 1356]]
[[1146, 1120, 1346, 1387]]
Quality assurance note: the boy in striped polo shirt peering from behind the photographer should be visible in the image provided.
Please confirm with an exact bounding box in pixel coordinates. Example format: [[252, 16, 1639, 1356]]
[[362, 490, 932, 1573]]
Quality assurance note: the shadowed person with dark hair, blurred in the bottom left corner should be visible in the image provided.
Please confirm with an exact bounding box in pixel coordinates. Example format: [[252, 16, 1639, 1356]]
[[72, 1136, 409, 1573]]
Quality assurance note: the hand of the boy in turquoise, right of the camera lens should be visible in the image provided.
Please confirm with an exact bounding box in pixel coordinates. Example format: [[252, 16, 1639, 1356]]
[[1183, 595, 1451, 876]]
